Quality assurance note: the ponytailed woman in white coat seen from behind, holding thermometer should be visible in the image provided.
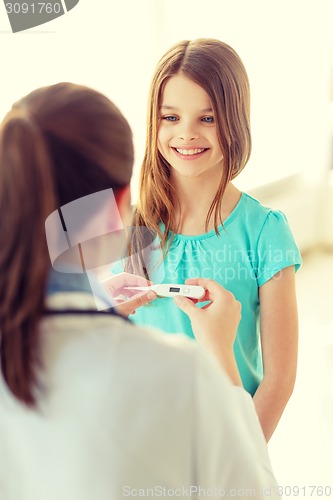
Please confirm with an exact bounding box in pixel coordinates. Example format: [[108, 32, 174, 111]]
[[0, 83, 278, 500]]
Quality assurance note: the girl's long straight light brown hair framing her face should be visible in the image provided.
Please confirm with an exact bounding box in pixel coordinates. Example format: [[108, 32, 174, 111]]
[[128, 38, 251, 269]]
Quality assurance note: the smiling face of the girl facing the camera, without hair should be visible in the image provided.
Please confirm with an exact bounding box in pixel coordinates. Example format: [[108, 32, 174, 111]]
[[157, 73, 223, 177]]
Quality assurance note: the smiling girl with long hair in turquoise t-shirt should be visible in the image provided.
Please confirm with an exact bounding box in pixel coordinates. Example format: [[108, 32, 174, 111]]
[[122, 39, 301, 440]]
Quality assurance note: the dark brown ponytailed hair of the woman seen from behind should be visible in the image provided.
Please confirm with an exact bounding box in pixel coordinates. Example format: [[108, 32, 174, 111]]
[[0, 83, 133, 406]]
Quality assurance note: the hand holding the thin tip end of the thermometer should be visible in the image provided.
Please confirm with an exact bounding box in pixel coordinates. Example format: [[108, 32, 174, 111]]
[[100, 273, 156, 317]]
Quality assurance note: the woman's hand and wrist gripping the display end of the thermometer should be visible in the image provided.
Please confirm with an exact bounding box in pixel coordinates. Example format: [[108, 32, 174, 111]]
[[174, 278, 242, 385]]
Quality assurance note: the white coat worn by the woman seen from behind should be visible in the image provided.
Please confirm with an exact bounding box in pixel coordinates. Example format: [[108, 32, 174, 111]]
[[0, 293, 278, 500]]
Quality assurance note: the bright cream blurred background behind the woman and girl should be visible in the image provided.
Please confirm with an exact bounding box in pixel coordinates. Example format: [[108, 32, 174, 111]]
[[0, 0, 333, 492]]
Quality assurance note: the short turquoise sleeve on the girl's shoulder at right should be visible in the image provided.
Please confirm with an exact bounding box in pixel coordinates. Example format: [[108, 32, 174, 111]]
[[256, 210, 302, 287]]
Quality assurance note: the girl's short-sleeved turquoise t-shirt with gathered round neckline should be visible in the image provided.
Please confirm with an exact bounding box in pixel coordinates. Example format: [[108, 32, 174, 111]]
[[114, 193, 302, 395]]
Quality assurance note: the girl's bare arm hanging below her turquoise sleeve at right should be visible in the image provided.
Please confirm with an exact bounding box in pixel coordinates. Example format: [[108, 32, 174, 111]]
[[253, 266, 298, 442]]
